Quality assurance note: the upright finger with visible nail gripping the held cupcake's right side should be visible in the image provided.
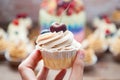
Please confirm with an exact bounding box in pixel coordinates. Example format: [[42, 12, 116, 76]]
[[69, 51, 84, 80]]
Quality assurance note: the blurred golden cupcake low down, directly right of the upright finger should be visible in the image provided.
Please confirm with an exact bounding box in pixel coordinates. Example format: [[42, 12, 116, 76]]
[[84, 48, 97, 71]]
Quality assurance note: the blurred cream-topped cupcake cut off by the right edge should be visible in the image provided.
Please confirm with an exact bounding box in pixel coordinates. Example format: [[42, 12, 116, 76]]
[[109, 29, 120, 62]]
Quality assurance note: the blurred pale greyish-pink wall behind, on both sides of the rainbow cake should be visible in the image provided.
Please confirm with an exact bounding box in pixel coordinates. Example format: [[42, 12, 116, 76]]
[[0, 0, 120, 22]]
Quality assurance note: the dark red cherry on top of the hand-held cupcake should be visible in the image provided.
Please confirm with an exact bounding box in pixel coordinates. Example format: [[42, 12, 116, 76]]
[[50, 22, 67, 32]]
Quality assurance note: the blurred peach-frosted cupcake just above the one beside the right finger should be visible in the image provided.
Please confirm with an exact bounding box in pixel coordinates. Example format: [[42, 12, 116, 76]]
[[82, 29, 108, 59]]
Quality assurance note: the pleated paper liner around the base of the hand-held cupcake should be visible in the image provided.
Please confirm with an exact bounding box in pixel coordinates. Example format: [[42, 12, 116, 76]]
[[41, 50, 77, 69]]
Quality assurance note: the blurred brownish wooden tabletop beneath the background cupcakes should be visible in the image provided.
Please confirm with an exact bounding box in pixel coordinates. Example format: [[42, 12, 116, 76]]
[[0, 26, 120, 80]]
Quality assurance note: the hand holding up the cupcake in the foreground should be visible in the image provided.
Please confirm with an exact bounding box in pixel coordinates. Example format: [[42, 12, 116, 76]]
[[18, 50, 84, 80]]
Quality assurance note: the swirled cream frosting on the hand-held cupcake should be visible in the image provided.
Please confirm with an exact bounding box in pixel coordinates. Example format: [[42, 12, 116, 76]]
[[36, 30, 81, 51]]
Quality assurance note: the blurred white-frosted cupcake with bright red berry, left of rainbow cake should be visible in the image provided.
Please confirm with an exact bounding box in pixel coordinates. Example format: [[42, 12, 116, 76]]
[[7, 19, 29, 43]]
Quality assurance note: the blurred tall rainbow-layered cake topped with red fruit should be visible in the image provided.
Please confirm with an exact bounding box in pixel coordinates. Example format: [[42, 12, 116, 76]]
[[39, 0, 86, 41]]
